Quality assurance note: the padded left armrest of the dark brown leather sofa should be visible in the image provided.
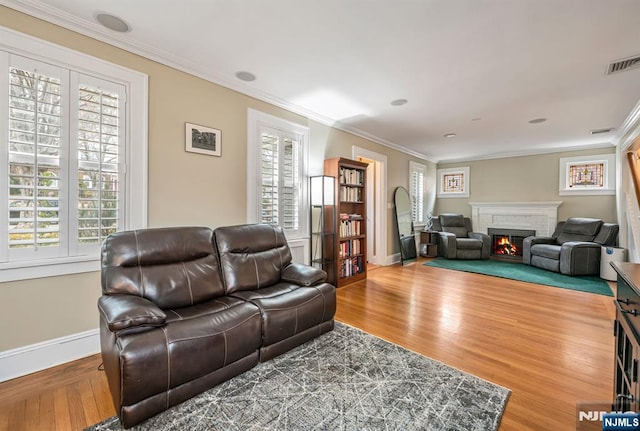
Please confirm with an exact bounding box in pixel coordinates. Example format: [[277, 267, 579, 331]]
[[98, 295, 167, 332]]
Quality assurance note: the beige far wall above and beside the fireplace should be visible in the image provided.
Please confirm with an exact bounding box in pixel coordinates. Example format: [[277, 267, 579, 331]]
[[436, 147, 617, 222]]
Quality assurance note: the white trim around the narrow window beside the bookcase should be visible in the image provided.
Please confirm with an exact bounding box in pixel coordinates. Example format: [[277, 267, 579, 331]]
[[247, 108, 309, 240]]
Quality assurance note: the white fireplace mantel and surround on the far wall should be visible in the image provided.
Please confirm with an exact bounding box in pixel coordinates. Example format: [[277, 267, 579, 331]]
[[469, 201, 562, 236]]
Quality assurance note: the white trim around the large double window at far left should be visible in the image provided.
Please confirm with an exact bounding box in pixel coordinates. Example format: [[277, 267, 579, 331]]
[[0, 27, 149, 282]]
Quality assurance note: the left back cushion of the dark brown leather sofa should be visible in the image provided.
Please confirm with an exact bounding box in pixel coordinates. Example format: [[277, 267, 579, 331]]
[[102, 227, 224, 309]]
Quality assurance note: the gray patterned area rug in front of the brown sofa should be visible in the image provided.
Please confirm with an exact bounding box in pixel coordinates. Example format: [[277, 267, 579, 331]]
[[87, 322, 510, 431]]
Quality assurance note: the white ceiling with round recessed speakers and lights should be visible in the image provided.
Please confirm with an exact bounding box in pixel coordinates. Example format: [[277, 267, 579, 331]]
[[5, 0, 640, 162]]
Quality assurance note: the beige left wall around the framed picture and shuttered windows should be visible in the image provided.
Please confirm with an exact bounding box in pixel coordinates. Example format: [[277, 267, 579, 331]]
[[0, 6, 435, 352]]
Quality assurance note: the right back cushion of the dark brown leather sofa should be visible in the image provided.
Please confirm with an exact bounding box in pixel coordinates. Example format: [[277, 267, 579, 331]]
[[214, 224, 291, 293]]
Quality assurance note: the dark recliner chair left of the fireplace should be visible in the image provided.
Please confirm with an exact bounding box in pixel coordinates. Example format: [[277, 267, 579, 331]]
[[433, 214, 491, 259]]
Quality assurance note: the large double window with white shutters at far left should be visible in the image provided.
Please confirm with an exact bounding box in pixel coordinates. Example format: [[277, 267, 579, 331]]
[[0, 32, 146, 281]]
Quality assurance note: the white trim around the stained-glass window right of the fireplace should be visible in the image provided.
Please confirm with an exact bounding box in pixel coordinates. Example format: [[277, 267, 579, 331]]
[[558, 154, 616, 196]]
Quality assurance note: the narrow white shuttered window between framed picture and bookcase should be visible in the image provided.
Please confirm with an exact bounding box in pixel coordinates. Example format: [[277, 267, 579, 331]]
[[247, 110, 308, 238]]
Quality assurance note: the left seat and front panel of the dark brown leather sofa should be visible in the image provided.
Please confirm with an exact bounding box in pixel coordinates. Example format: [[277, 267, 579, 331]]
[[118, 302, 261, 405]]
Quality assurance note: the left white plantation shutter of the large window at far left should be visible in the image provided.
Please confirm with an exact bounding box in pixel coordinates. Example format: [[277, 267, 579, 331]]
[[3, 56, 67, 260]]
